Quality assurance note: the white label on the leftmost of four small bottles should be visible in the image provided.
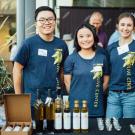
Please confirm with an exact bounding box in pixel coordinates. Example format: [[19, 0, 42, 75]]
[[55, 113, 62, 129]]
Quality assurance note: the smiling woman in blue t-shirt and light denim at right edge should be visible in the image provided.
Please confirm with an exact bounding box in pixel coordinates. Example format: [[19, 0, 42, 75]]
[[106, 12, 135, 118]]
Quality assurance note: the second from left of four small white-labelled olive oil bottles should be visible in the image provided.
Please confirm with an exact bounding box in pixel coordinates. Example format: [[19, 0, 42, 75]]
[[63, 101, 71, 133]]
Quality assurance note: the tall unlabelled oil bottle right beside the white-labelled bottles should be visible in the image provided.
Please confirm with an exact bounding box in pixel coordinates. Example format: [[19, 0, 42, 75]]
[[46, 89, 55, 132]]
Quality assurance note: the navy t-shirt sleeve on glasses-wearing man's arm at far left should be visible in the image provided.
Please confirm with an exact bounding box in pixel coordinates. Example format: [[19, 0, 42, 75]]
[[14, 41, 29, 66]]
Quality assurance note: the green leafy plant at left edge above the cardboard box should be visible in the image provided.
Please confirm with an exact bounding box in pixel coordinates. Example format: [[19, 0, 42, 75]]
[[0, 57, 14, 104]]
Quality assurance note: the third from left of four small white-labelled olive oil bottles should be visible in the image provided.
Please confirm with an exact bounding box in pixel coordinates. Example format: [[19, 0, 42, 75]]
[[73, 100, 80, 133]]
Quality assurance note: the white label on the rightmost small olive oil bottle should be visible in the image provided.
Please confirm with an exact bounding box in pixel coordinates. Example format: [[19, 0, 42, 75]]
[[81, 112, 89, 129]]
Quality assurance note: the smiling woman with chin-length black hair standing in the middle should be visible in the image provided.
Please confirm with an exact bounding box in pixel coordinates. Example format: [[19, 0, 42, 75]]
[[64, 24, 109, 120]]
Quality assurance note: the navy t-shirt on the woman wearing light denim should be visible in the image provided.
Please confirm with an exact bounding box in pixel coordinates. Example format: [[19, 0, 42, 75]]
[[108, 40, 135, 90]]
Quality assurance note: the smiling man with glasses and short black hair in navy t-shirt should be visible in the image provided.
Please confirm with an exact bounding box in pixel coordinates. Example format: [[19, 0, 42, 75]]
[[13, 6, 68, 117]]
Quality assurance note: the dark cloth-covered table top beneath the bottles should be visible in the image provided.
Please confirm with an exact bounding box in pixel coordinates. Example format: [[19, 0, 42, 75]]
[[33, 118, 135, 135]]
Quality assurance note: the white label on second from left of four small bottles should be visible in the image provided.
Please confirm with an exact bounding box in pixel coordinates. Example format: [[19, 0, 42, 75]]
[[63, 113, 71, 129]]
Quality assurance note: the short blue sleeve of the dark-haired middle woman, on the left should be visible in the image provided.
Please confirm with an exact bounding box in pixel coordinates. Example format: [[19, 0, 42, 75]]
[[64, 55, 74, 74]]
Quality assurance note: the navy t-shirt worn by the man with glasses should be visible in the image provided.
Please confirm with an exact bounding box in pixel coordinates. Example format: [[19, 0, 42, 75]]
[[15, 35, 68, 103]]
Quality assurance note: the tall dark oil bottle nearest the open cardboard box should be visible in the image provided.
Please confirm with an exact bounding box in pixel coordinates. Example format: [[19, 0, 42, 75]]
[[34, 89, 44, 132]]
